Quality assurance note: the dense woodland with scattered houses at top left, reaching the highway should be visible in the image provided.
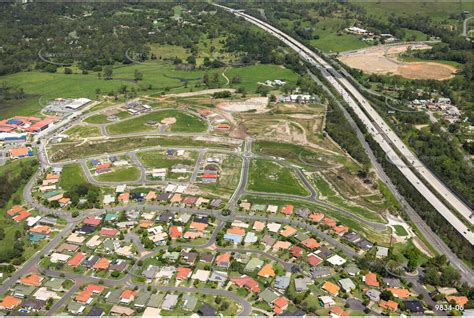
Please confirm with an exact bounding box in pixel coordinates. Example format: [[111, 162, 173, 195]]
[[0, 2, 299, 75]]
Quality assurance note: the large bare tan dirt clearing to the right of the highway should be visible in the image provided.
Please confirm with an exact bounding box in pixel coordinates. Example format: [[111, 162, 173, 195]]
[[339, 43, 457, 80]]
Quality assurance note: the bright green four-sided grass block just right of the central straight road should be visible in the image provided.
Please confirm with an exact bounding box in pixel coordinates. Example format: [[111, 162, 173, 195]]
[[247, 160, 309, 196]]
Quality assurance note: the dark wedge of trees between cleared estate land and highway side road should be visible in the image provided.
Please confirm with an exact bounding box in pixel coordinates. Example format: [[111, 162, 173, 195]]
[[325, 100, 369, 165]]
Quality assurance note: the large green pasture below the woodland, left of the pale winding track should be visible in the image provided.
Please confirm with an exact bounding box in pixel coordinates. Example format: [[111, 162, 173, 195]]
[[0, 61, 205, 118]]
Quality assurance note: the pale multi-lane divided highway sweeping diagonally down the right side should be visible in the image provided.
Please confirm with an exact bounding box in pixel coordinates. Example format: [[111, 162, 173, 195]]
[[214, 4, 474, 245]]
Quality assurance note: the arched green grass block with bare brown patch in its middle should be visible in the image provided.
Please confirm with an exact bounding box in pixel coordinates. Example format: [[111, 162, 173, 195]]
[[107, 109, 207, 135]]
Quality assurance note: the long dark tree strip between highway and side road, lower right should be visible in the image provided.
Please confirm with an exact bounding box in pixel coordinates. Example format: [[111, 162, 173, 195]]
[[366, 136, 474, 263]]
